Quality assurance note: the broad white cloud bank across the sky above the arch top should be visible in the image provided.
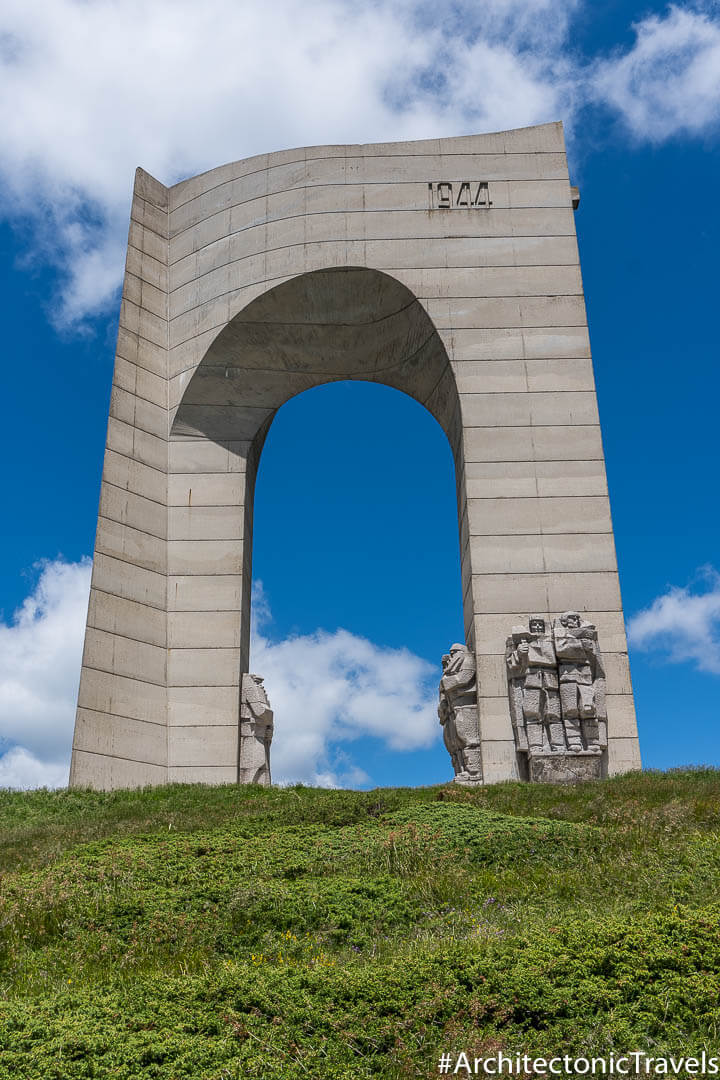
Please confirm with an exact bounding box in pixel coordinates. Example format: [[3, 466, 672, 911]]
[[9, 0, 720, 324]]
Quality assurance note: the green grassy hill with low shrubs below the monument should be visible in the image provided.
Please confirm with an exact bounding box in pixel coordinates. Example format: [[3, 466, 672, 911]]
[[0, 770, 720, 1080]]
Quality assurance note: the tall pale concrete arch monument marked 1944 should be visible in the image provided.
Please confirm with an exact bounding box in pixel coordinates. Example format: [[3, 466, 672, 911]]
[[70, 124, 639, 788]]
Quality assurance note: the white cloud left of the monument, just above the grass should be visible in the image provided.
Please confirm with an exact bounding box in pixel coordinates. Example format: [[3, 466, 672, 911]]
[[0, 559, 91, 787]]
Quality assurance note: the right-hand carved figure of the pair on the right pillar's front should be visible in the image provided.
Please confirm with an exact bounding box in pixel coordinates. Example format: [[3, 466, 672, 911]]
[[553, 611, 607, 754]]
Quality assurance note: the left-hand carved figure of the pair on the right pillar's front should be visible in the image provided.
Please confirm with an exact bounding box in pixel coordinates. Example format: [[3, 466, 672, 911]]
[[505, 616, 566, 755]]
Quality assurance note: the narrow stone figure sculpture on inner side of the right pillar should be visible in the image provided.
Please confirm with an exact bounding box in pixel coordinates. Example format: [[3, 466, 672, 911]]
[[437, 644, 483, 784]]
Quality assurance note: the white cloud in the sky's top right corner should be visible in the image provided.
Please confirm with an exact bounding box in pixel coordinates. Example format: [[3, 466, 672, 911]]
[[592, 5, 720, 143]]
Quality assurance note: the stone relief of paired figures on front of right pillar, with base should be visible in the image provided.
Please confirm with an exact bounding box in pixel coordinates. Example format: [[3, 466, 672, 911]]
[[505, 611, 608, 780]]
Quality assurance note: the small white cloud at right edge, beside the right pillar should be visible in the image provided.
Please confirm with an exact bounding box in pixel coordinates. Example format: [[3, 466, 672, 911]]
[[627, 567, 720, 675]]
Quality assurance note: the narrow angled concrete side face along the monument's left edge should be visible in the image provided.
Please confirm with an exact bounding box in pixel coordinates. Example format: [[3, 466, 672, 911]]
[[70, 168, 168, 788]]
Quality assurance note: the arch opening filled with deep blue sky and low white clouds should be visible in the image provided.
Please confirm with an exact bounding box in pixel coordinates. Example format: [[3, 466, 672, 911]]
[[249, 381, 462, 786]]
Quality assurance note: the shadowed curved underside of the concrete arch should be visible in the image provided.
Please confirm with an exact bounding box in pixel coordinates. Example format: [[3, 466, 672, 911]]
[[172, 267, 459, 449]]
